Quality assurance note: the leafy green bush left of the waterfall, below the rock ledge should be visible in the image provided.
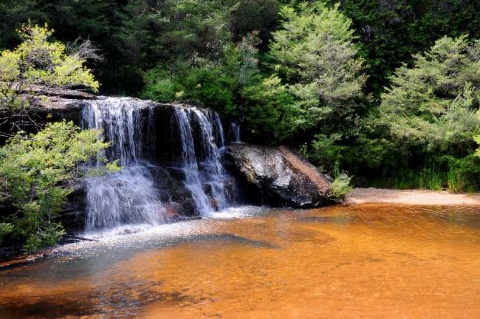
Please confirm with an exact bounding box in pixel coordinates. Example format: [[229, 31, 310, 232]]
[[0, 122, 107, 251]]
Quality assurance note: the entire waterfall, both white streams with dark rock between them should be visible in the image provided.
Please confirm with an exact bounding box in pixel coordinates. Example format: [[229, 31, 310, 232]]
[[83, 98, 231, 231]]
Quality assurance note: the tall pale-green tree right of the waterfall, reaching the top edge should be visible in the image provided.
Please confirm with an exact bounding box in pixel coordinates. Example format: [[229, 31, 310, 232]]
[[270, 1, 365, 134]]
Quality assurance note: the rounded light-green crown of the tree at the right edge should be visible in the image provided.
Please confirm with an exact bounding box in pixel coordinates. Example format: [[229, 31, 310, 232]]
[[380, 37, 480, 150]]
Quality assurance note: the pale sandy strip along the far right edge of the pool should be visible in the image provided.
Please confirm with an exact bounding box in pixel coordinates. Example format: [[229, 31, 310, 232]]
[[345, 188, 480, 206]]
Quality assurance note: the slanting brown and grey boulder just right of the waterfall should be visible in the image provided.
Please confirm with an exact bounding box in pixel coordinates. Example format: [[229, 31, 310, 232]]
[[227, 144, 331, 208]]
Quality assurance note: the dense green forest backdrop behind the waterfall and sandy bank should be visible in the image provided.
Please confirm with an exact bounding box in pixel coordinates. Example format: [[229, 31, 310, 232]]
[[0, 0, 480, 250]]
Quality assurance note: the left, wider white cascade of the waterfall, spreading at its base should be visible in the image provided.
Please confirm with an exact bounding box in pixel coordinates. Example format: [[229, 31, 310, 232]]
[[83, 98, 166, 231]]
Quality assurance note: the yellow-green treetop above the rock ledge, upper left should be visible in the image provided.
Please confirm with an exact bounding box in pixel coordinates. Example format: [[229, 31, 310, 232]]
[[0, 25, 99, 136]]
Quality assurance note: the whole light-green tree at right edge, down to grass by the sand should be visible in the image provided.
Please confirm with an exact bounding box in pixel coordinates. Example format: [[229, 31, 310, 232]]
[[377, 36, 480, 191]]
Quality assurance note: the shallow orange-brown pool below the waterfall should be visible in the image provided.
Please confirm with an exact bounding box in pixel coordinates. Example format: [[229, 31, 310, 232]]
[[0, 205, 480, 319]]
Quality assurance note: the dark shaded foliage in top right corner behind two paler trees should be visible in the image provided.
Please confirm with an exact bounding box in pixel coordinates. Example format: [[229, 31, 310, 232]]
[[320, 0, 480, 97]]
